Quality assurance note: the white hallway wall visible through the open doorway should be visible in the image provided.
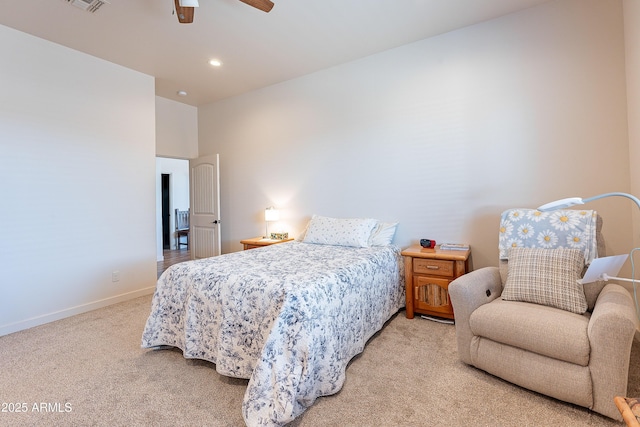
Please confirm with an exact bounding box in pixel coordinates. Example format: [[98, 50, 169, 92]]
[[156, 157, 189, 261]]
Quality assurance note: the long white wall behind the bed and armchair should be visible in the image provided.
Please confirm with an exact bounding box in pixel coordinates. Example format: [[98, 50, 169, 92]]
[[199, 0, 630, 268]]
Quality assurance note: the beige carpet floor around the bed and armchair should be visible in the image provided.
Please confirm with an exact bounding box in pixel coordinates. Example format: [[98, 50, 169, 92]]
[[0, 296, 640, 427]]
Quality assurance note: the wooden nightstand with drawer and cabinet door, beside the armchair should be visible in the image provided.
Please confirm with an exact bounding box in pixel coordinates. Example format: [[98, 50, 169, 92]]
[[402, 245, 471, 319]]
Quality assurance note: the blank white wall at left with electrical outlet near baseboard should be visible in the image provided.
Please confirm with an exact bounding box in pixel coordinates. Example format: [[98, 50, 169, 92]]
[[0, 26, 156, 335]]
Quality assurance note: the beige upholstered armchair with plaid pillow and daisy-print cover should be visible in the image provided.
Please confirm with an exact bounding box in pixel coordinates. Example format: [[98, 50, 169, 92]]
[[449, 209, 638, 420]]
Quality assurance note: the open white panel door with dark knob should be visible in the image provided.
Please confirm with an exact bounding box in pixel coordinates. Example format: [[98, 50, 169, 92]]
[[189, 154, 221, 259]]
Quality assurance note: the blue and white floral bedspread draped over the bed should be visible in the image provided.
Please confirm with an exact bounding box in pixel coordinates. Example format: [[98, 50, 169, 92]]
[[142, 242, 405, 426]]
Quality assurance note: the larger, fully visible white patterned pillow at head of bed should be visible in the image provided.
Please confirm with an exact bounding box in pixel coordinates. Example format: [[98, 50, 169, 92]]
[[303, 215, 377, 248]]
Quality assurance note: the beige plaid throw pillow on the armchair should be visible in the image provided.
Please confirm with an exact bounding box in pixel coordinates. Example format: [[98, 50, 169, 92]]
[[502, 248, 587, 314]]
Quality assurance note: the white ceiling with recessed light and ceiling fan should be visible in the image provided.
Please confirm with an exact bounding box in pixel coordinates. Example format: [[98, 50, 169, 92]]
[[0, 0, 549, 106]]
